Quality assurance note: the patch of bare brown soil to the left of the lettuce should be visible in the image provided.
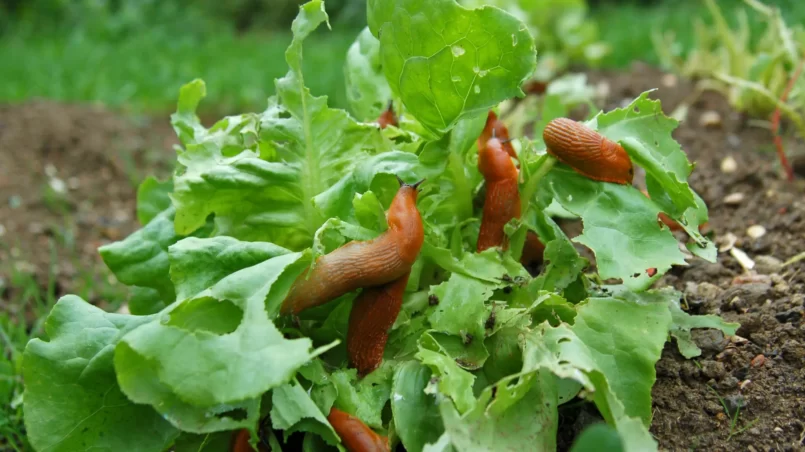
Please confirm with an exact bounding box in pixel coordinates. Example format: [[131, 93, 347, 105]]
[[0, 101, 174, 308]]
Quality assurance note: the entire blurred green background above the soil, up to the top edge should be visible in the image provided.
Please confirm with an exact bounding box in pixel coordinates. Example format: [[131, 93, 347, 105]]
[[0, 0, 805, 113]]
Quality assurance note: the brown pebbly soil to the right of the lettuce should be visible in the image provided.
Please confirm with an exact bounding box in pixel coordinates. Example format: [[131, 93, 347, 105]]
[[591, 65, 805, 451]]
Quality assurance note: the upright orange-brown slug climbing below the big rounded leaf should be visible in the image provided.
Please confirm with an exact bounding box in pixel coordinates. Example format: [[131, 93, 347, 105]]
[[477, 138, 520, 251]]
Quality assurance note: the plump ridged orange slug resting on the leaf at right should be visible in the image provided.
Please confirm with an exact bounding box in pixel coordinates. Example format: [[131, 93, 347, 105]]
[[542, 118, 634, 185]]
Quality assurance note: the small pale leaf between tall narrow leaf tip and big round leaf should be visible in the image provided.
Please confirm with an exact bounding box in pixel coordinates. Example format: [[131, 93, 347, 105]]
[[344, 27, 391, 122]]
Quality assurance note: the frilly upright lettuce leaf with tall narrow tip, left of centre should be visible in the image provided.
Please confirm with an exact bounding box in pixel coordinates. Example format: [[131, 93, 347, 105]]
[[172, 0, 400, 250]]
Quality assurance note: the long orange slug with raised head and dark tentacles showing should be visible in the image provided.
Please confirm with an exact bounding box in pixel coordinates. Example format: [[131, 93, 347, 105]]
[[280, 180, 425, 314]]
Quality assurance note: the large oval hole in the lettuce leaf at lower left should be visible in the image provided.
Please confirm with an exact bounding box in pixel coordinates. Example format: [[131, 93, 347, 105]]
[[167, 297, 243, 335]]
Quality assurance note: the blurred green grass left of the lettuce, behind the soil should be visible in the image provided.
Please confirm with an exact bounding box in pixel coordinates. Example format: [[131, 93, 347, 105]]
[[0, 30, 358, 114]]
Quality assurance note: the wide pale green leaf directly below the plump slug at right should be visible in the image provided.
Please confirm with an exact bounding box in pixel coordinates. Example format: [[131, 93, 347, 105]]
[[541, 167, 686, 290]]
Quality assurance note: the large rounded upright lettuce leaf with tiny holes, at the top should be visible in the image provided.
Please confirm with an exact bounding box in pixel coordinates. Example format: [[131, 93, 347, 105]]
[[367, 0, 536, 134]]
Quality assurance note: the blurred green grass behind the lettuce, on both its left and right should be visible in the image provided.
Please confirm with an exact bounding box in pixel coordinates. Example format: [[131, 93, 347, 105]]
[[0, 0, 805, 114]]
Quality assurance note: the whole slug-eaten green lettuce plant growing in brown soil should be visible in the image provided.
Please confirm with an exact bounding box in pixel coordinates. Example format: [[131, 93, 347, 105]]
[[24, 0, 736, 451]]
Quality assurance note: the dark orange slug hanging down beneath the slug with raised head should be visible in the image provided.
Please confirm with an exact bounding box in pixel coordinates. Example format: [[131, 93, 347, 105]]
[[347, 272, 410, 377]]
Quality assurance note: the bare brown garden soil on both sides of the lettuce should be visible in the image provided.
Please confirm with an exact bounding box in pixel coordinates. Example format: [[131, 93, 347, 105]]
[[0, 66, 805, 452]]
